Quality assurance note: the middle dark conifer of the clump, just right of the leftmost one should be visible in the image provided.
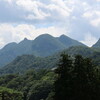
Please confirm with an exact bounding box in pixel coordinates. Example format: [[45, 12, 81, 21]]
[[72, 55, 87, 100]]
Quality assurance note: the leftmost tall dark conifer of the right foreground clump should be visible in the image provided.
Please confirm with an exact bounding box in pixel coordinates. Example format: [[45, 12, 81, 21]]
[[54, 54, 73, 100]]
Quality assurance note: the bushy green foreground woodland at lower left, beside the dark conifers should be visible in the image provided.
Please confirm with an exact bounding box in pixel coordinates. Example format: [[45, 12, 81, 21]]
[[0, 69, 56, 100]]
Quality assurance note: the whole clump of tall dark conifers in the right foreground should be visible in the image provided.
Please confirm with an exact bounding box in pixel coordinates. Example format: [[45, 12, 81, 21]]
[[53, 54, 100, 100]]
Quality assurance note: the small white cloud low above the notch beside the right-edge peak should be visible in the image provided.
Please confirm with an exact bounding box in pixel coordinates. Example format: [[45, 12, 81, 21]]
[[81, 33, 97, 47]]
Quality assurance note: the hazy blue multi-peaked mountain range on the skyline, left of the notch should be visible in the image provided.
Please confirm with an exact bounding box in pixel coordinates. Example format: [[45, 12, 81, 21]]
[[0, 34, 85, 66]]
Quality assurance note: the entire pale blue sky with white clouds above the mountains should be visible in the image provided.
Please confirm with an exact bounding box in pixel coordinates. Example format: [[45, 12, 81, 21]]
[[0, 0, 100, 48]]
